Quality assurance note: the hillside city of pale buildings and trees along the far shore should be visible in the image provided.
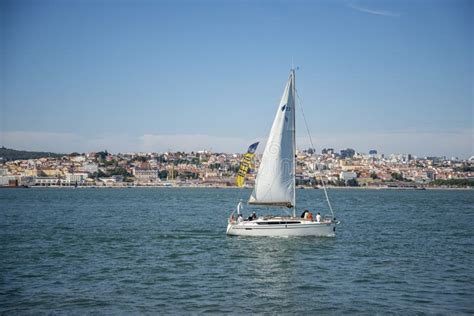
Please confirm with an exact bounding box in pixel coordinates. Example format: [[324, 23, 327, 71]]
[[0, 148, 474, 188]]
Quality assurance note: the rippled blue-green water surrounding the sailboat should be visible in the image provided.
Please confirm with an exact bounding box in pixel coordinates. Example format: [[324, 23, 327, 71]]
[[0, 188, 474, 314]]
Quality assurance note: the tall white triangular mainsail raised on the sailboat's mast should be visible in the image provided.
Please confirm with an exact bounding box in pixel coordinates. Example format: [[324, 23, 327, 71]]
[[249, 70, 296, 207]]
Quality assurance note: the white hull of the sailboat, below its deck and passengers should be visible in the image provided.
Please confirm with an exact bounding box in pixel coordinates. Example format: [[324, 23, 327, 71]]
[[227, 218, 336, 237]]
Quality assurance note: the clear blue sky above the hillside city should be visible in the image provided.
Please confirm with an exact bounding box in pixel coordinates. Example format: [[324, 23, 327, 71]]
[[0, 0, 474, 158]]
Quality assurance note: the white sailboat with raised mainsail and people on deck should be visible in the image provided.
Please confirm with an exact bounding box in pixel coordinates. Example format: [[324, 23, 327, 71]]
[[227, 69, 339, 237]]
